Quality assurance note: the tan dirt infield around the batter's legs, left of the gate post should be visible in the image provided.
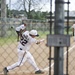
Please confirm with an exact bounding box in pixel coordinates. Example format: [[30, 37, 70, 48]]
[[0, 41, 49, 75]]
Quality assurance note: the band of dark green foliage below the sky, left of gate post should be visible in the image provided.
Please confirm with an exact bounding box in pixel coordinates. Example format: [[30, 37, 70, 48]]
[[7, 7, 49, 20]]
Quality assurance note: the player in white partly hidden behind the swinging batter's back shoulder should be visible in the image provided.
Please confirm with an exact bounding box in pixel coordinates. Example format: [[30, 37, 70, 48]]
[[16, 23, 26, 41]]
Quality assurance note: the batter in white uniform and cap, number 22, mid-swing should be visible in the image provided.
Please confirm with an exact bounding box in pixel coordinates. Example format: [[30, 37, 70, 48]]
[[3, 30, 44, 75]]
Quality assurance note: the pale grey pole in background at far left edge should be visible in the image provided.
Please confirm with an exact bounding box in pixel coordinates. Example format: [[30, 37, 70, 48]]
[[0, 0, 6, 37]]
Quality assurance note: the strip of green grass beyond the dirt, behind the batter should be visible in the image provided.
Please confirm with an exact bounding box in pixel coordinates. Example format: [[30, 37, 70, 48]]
[[0, 30, 72, 46]]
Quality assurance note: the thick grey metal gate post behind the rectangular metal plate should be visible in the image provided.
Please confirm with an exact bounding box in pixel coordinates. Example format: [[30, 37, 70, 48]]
[[54, 0, 64, 75]]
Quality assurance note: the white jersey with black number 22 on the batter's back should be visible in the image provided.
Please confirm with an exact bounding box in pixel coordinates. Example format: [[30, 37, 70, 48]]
[[18, 31, 37, 51]]
